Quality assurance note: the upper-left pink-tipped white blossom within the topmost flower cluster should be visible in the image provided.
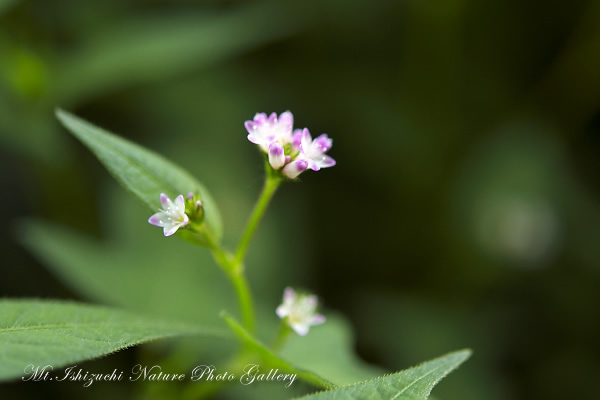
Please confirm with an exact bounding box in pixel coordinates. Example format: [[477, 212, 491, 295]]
[[244, 111, 294, 153]]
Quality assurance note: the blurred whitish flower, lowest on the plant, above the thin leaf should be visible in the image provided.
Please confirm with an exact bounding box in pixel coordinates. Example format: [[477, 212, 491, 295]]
[[276, 288, 325, 336]]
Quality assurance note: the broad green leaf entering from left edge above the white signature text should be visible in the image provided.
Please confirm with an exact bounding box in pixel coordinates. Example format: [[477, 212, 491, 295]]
[[0, 300, 224, 380]]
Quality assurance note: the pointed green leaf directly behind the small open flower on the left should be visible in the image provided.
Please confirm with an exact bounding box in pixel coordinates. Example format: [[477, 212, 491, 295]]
[[56, 110, 222, 242]]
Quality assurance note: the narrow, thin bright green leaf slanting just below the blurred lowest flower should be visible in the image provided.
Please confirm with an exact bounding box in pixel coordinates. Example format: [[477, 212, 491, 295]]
[[223, 313, 336, 388]]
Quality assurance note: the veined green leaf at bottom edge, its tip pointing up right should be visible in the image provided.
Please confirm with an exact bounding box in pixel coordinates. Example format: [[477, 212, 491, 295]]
[[301, 350, 471, 400]]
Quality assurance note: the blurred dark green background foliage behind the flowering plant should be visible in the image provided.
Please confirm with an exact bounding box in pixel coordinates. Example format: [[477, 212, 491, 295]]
[[0, 0, 600, 400]]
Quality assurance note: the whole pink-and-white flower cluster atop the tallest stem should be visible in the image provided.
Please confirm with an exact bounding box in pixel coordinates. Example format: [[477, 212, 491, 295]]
[[244, 111, 335, 179]]
